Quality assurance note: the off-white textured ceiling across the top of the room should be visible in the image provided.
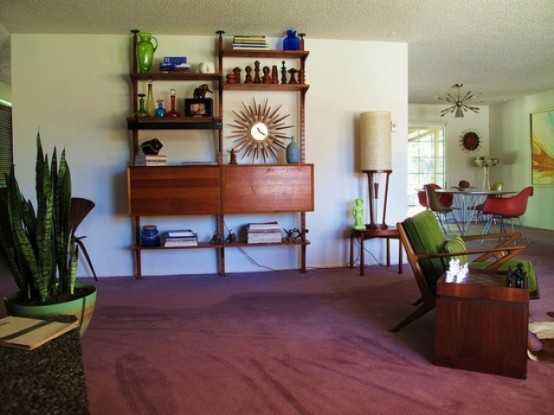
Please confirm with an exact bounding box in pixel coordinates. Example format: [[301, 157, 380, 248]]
[[0, 0, 554, 105]]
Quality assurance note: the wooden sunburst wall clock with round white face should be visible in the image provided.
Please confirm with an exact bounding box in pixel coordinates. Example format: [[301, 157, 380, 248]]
[[229, 98, 293, 163]]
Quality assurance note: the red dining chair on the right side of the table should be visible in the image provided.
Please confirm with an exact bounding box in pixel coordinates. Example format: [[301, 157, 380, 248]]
[[483, 186, 533, 246]]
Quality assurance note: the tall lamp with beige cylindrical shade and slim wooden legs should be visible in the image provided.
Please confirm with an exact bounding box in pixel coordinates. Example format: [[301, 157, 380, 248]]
[[360, 111, 392, 229]]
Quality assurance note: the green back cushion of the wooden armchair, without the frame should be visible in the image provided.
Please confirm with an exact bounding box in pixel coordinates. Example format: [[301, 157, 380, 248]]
[[398, 210, 446, 292]]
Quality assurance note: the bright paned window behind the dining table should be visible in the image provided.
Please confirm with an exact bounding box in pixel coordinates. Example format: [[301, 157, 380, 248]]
[[408, 124, 446, 207]]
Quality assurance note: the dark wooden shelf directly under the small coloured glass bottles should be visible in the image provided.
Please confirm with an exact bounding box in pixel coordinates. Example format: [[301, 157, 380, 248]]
[[127, 117, 223, 130]]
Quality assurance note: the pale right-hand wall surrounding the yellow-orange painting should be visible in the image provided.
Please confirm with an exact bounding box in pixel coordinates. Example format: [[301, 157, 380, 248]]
[[490, 90, 554, 229]]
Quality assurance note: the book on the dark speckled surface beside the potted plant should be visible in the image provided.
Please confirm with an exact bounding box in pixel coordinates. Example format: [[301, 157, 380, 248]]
[[0, 316, 79, 350]]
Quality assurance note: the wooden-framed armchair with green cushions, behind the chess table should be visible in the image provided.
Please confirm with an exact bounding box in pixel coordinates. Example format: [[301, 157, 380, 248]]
[[391, 210, 538, 331]]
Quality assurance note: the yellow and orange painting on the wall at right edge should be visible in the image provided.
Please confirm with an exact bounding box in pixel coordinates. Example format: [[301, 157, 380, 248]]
[[531, 108, 554, 186]]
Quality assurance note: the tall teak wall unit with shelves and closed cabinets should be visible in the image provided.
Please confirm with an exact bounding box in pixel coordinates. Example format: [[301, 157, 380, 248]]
[[127, 31, 314, 279]]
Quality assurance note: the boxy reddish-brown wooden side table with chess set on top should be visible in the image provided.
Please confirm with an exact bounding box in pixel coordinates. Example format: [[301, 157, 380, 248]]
[[435, 271, 529, 379]]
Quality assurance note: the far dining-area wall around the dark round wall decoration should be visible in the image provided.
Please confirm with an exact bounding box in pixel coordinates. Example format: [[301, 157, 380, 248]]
[[409, 104, 488, 188]]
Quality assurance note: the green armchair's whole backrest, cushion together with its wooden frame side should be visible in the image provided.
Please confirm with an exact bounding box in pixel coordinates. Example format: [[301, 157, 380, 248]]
[[398, 210, 446, 295]]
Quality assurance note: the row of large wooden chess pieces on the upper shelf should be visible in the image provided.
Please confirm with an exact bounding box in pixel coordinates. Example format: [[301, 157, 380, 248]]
[[226, 61, 306, 85]]
